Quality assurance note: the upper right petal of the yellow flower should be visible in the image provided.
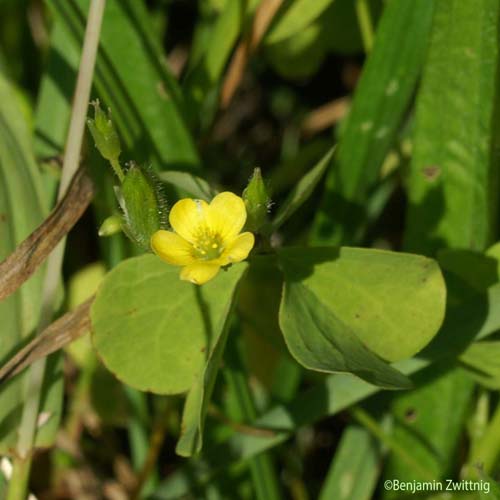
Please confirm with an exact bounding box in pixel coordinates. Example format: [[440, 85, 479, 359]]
[[207, 191, 247, 242]]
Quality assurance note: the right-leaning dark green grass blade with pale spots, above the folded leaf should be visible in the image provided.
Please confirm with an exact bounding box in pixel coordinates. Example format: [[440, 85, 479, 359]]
[[312, 0, 434, 244]]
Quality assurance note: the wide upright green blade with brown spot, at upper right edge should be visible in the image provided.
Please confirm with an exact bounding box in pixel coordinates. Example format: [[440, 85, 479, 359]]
[[405, 0, 500, 254]]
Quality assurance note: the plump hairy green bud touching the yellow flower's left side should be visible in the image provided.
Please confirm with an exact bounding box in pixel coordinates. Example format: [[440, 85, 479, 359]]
[[118, 164, 166, 251]]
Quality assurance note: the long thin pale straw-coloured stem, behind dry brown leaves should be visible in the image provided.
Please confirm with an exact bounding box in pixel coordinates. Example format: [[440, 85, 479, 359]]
[[7, 0, 106, 500]]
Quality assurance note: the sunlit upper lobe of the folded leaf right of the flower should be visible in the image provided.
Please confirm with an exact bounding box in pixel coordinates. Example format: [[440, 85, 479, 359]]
[[279, 247, 446, 361]]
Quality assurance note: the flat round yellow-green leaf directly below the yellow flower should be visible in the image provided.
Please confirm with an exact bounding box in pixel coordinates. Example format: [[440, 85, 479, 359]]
[[91, 255, 246, 394]]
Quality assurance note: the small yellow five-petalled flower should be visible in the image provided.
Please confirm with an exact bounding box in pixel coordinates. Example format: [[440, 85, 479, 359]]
[[151, 192, 255, 285]]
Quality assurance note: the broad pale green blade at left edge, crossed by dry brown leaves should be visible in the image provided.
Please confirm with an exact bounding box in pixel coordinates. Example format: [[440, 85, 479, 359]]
[[0, 75, 62, 454]]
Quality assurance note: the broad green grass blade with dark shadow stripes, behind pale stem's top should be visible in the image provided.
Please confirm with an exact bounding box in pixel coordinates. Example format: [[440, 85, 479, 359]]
[[48, 0, 199, 170]]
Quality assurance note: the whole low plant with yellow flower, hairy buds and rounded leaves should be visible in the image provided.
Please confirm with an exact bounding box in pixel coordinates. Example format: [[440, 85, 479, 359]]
[[88, 102, 446, 456]]
